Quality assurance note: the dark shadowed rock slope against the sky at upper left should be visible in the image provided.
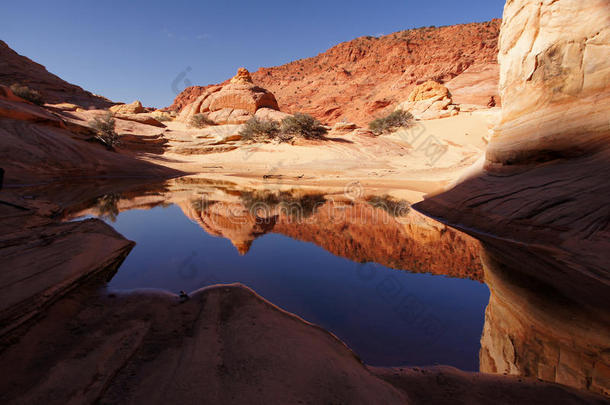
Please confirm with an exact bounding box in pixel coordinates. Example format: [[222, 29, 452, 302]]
[[0, 40, 114, 108]]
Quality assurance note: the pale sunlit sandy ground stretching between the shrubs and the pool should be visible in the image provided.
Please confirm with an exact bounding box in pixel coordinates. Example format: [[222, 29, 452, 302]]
[[141, 110, 497, 198]]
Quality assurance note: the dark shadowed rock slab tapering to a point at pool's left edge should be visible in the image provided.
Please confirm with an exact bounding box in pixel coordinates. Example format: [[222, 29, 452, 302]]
[[0, 202, 134, 336]]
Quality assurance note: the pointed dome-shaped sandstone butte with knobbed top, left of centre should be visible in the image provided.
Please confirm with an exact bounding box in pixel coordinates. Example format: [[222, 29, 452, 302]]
[[178, 68, 279, 124]]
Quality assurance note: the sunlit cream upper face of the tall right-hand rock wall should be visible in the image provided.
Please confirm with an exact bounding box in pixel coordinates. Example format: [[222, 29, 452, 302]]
[[487, 0, 610, 166]]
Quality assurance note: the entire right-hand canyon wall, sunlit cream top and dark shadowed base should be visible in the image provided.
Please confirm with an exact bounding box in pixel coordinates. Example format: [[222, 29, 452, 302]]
[[416, 0, 610, 258]]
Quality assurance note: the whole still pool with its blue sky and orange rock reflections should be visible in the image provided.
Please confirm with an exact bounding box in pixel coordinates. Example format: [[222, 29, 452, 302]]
[[51, 174, 610, 394]]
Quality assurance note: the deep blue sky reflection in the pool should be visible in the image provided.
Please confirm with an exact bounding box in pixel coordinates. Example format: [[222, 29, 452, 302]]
[[101, 205, 489, 370]]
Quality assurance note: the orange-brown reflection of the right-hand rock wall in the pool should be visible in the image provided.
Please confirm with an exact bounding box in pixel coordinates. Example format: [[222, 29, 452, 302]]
[[480, 243, 610, 395]]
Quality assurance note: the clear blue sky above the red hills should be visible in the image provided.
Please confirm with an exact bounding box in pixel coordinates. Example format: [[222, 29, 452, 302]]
[[0, 0, 504, 107]]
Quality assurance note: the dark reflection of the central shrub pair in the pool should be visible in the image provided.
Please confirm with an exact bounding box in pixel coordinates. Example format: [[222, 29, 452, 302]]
[[241, 191, 326, 219]]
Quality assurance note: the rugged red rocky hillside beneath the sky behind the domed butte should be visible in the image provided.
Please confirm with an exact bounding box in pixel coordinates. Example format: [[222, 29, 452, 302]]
[[169, 20, 500, 126]]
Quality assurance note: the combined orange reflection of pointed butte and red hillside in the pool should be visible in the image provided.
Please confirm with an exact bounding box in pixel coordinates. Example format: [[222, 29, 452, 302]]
[[179, 189, 482, 280]]
